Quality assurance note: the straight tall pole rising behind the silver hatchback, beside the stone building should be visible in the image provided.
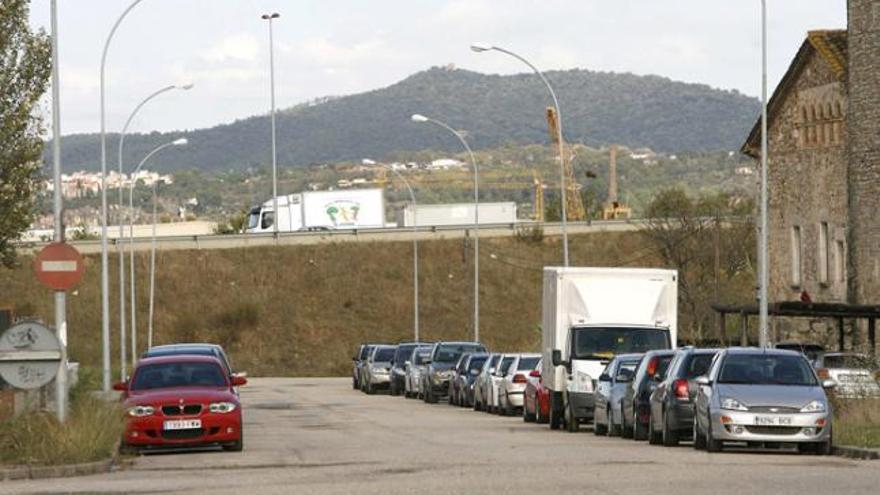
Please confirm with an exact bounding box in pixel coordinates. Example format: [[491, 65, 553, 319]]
[[758, 0, 770, 347]]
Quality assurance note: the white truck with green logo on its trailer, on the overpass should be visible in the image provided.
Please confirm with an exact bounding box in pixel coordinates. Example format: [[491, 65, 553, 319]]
[[247, 189, 385, 234]]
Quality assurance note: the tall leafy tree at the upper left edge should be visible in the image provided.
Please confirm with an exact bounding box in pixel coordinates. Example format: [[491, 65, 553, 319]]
[[0, 0, 52, 267]]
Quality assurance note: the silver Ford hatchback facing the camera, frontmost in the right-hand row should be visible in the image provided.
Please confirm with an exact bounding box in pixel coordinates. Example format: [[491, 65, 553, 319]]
[[694, 348, 834, 454]]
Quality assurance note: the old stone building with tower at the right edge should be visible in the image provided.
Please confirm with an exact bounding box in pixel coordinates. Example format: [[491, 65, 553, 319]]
[[742, 0, 880, 343]]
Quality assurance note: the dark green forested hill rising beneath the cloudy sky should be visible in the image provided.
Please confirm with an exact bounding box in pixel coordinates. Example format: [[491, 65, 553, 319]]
[[45, 68, 759, 170]]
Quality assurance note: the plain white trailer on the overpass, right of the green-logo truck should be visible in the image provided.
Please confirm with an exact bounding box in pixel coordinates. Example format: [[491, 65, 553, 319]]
[[397, 201, 516, 227]]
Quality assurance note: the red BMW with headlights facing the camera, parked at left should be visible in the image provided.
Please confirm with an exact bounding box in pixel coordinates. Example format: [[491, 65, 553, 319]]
[[113, 355, 247, 451]]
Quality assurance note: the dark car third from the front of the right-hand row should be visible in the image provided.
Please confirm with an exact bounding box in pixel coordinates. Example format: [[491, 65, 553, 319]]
[[620, 350, 675, 440]]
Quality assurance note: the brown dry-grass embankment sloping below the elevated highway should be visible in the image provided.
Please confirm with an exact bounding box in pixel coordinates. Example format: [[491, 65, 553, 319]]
[[0, 232, 659, 376]]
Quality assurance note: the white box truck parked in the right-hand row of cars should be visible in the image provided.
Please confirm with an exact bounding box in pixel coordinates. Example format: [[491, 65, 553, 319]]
[[541, 267, 678, 431]]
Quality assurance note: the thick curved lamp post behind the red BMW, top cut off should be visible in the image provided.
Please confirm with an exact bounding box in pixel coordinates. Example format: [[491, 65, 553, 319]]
[[100, 0, 143, 392]]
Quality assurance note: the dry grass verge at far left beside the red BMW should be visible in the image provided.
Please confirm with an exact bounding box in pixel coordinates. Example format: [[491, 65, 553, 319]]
[[0, 374, 123, 465]]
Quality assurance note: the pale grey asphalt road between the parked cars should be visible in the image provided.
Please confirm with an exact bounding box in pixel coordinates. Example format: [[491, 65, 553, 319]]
[[0, 378, 880, 495]]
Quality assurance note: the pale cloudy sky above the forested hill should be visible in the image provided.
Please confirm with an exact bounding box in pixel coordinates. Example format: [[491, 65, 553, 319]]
[[31, 0, 846, 134]]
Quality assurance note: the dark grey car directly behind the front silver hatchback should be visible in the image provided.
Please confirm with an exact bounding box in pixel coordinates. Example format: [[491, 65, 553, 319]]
[[648, 347, 718, 447]]
